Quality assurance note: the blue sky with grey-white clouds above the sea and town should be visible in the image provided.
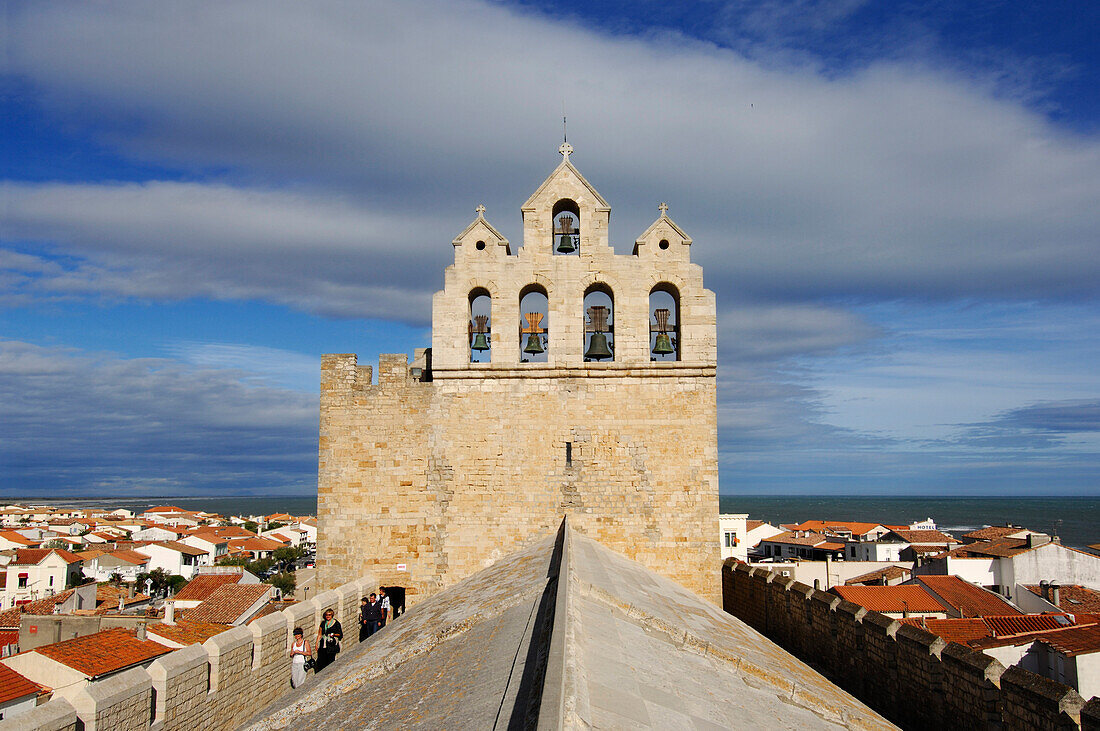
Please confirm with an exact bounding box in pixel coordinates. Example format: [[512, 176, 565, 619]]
[[0, 0, 1100, 496]]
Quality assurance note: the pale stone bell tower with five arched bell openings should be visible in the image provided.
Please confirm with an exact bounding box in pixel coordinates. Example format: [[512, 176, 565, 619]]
[[318, 143, 721, 602]]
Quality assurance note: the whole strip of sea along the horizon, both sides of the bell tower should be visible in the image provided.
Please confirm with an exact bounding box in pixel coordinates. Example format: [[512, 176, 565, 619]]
[[10, 495, 1100, 547]]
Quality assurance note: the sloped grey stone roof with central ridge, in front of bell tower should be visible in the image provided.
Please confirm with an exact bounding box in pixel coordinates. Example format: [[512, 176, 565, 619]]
[[245, 524, 894, 731]]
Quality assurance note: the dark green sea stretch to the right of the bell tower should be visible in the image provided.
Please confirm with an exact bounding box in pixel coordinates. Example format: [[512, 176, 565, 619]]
[[718, 495, 1100, 547]]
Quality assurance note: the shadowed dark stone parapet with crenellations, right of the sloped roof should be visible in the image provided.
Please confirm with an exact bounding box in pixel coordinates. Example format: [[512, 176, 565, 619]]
[[722, 560, 1096, 731]]
